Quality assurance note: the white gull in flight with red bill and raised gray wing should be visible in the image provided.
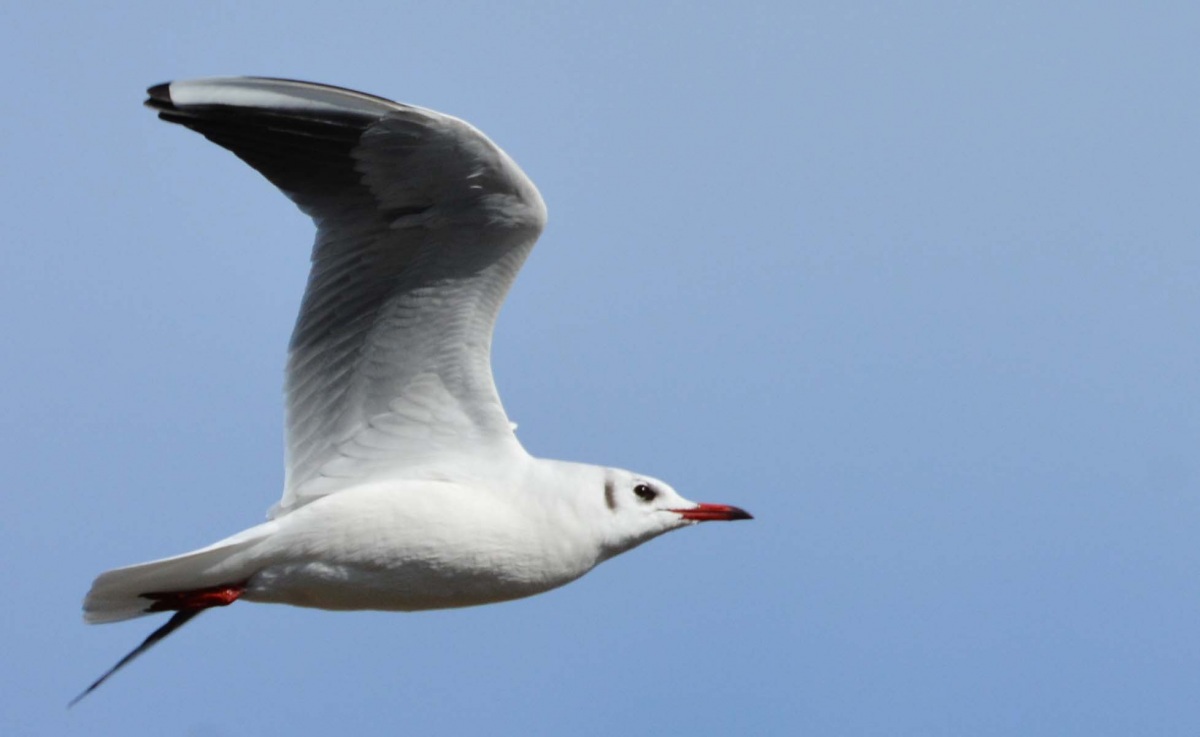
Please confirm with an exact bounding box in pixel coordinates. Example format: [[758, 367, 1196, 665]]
[[71, 77, 751, 705]]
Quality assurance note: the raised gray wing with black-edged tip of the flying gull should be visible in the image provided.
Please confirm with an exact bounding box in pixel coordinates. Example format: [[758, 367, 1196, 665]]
[[146, 78, 546, 516]]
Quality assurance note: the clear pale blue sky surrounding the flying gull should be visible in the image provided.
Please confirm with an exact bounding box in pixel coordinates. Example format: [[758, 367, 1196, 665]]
[[0, 1, 1200, 737]]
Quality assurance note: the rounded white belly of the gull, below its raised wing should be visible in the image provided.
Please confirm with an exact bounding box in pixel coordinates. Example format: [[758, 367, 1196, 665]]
[[242, 483, 598, 611]]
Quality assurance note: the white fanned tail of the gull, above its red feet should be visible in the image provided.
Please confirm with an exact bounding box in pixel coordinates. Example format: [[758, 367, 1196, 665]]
[[83, 522, 275, 624]]
